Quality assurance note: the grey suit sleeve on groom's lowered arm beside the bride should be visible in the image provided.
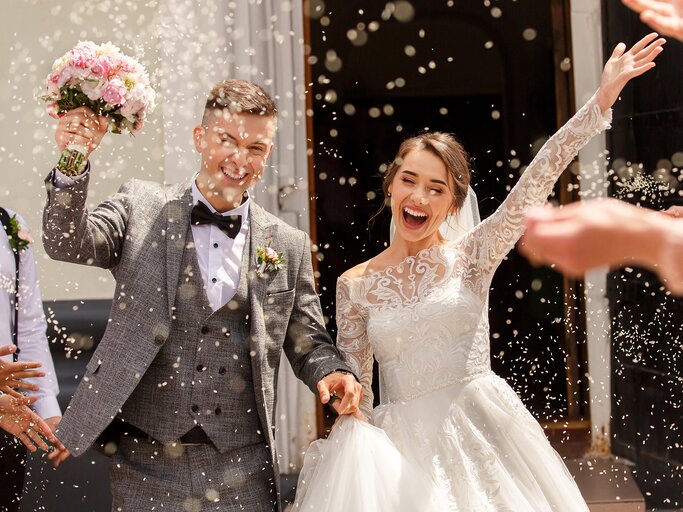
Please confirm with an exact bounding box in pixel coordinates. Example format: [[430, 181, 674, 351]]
[[284, 233, 358, 393]]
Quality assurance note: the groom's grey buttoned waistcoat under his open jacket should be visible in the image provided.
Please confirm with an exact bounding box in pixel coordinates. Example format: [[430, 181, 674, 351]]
[[119, 227, 265, 452]]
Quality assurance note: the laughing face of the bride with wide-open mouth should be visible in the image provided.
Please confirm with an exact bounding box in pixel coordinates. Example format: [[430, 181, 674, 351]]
[[388, 149, 455, 242]]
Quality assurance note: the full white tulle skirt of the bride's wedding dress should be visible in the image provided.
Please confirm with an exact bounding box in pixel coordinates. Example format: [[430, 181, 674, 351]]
[[295, 374, 588, 512]]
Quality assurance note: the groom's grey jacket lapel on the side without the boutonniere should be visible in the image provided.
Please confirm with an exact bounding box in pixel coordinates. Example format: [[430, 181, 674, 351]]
[[166, 184, 192, 317]]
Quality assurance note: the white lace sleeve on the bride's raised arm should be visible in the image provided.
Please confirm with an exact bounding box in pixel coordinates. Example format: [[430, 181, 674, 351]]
[[463, 95, 612, 295]]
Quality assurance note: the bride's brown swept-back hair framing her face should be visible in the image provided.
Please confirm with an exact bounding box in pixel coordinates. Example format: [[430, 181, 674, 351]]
[[377, 132, 470, 214]]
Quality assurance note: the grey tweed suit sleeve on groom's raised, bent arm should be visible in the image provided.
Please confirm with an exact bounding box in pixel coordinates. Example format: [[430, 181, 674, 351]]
[[43, 171, 135, 269]]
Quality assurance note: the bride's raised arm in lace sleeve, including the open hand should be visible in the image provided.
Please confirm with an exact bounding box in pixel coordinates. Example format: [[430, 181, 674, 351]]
[[464, 33, 665, 290]]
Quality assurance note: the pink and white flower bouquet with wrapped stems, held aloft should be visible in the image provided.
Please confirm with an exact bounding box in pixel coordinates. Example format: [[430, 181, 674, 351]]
[[41, 41, 155, 174]]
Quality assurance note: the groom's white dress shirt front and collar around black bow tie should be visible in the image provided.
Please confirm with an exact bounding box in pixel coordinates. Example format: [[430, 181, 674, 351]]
[[192, 180, 251, 311]]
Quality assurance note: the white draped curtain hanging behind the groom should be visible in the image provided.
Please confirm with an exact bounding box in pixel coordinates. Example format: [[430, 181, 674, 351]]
[[158, 0, 316, 472]]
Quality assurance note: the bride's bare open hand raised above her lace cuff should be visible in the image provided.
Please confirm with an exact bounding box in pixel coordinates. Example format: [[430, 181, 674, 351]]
[[597, 32, 666, 112]]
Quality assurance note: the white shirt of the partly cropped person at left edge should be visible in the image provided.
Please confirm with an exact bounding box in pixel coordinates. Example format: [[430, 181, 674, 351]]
[[0, 208, 62, 418]]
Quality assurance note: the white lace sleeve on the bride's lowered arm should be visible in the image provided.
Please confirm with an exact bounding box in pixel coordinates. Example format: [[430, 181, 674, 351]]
[[337, 277, 373, 418]]
